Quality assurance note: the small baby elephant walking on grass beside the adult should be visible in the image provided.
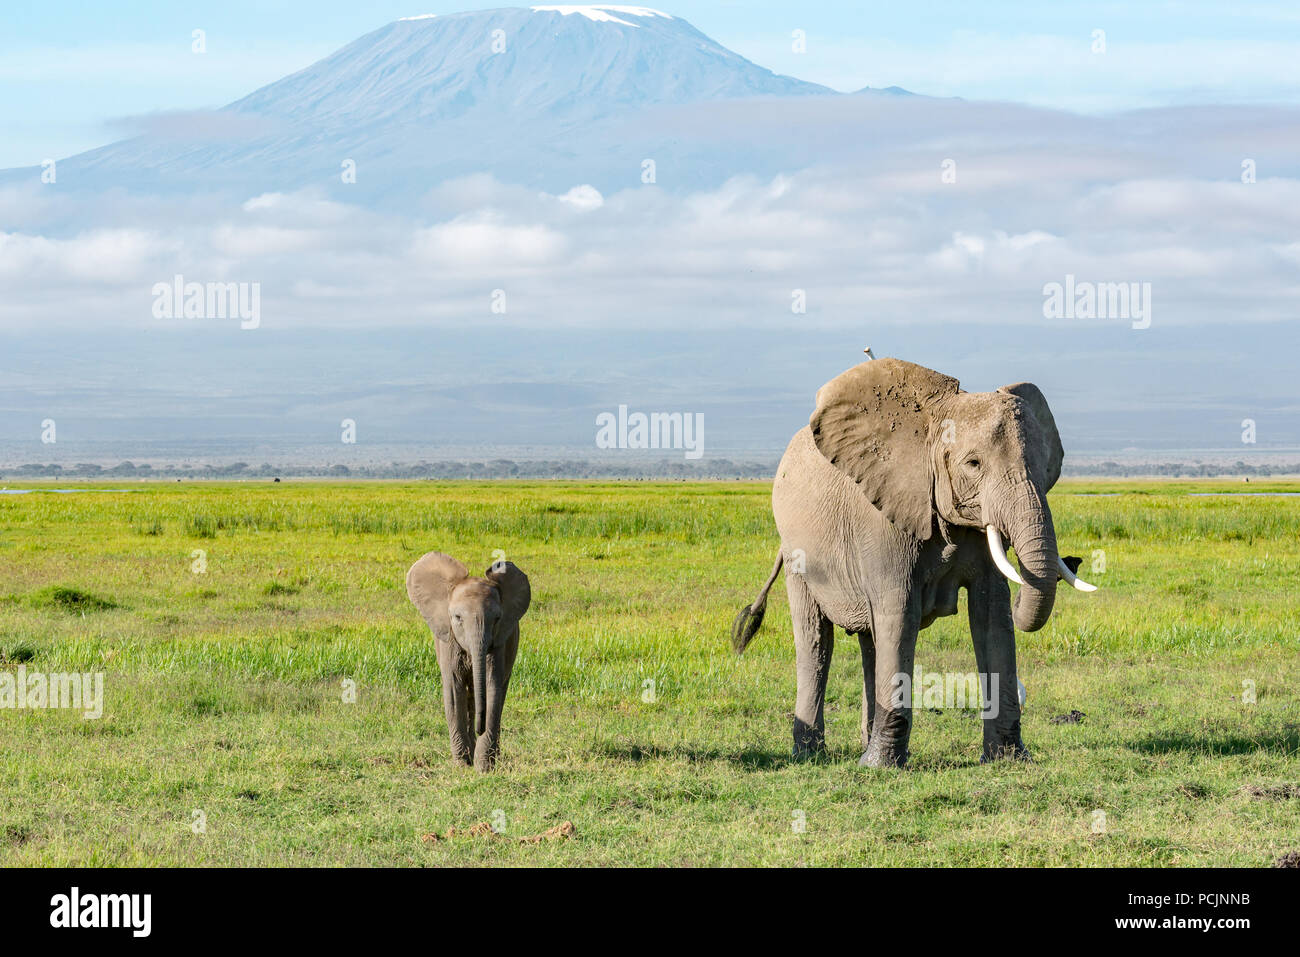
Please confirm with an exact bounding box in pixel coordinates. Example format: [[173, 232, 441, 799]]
[[407, 551, 532, 772]]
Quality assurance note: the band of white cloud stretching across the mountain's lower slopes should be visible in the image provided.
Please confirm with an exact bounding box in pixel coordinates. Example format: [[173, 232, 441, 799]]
[[0, 103, 1300, 329]]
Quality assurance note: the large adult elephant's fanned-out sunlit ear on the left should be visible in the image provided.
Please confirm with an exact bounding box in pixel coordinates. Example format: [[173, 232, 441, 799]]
[[809, 359, 959, 540]]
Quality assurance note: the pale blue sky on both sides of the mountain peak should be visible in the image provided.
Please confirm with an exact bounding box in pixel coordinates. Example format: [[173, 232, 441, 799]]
[[0, 0, 1300, 168]]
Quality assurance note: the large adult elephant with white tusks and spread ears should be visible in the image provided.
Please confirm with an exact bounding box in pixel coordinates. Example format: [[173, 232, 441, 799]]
[[732, 359, 1093, 767]]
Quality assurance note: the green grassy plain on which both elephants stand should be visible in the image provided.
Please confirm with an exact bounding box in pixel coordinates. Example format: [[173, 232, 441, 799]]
[[0, 480, 1300, 866]]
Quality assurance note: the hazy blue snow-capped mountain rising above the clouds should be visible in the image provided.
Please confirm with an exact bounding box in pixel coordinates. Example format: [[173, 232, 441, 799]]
[[5, 5, 894, 204]]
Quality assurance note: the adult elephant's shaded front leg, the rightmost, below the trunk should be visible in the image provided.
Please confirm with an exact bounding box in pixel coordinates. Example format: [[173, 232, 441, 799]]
[[967, 576, 1030, 763]]
